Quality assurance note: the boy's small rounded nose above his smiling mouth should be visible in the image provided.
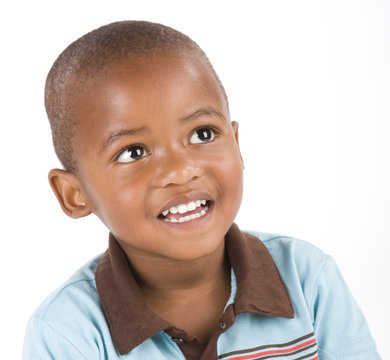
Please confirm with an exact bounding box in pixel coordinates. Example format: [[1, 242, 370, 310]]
[[155, 151, 202, 187]]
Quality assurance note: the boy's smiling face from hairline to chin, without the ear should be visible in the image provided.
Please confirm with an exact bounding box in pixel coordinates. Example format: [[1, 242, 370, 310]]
[[69, 55, 242, 260]]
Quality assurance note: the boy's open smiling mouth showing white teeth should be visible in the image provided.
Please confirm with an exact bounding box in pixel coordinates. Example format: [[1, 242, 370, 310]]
[[158, 200, 211, 223]]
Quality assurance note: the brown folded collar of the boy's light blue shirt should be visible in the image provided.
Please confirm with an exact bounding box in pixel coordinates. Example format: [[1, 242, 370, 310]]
[[95, 224, 294, 355]]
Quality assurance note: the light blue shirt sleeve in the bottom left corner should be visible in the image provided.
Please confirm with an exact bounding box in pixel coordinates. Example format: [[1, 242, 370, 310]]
[[23, 317, 87, 360]]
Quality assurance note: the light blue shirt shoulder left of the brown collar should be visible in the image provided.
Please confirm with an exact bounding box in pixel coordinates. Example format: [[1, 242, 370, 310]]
[[23, 254, 120, 359]]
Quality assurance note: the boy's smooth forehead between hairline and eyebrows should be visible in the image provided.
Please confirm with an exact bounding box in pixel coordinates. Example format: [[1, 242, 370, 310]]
[[70, 53, 228, 145]]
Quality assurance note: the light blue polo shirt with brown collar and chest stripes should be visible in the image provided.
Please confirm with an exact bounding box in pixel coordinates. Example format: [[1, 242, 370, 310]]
[[23, 225, 380, 360]]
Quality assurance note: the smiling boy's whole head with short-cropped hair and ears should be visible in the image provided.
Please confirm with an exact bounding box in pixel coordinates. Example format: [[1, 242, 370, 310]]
[[46, 22, 242, 260]]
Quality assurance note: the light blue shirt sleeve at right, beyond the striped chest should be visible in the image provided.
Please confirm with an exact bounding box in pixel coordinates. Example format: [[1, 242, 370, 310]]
[[310, 257, 381, 360]]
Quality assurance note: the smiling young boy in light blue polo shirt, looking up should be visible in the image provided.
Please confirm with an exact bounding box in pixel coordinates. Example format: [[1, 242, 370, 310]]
[[24, 21, 379, 360]]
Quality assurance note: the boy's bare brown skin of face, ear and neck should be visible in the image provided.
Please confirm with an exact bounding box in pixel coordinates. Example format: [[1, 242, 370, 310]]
[[49, 50, 243, 343]]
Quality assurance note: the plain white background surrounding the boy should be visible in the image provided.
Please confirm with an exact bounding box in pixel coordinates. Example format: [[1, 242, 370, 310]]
[[0, 0, 390, 359]]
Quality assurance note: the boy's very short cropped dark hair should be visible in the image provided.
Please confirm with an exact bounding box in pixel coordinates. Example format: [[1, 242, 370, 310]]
[[45, 21, 227, 171]]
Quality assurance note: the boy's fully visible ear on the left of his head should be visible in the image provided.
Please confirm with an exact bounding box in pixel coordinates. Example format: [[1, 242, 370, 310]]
[[49, 169, 91, 219]]
